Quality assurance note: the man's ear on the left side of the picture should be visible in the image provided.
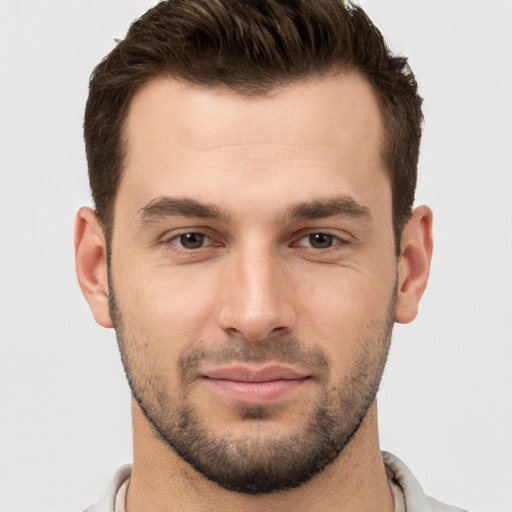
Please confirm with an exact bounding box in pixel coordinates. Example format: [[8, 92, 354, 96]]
[[75, 207, 112, 327]]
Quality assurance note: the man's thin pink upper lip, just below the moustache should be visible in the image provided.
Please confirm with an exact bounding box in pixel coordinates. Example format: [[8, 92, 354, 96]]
[[202, 364, 309, 382]]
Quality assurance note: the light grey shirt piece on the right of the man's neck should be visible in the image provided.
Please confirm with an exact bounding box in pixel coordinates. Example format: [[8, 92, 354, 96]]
[[382, 452, 467, 512]]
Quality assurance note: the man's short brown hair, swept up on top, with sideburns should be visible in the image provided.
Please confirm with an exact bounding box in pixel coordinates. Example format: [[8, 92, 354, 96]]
[[84, 0, 423, 250]]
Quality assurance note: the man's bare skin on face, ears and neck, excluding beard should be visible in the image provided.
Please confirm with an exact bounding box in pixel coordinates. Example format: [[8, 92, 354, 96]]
[[75, 72, 432, 512]]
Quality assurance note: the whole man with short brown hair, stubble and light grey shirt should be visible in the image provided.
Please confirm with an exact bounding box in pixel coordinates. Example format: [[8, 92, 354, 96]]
[[75, 0, 468, 512]]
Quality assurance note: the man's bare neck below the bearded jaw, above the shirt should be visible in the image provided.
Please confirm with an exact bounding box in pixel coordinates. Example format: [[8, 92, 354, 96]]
[[126, 401, 394, 512]]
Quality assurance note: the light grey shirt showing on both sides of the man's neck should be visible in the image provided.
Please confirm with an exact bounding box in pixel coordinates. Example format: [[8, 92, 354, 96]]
[[84, 452, 467, 512]]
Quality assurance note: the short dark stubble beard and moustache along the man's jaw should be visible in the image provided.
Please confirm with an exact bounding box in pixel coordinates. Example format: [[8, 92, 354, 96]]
[[109, 286, 396, 495]]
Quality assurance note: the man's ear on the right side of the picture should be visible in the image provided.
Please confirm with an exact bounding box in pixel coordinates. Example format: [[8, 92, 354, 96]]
[[395, 206, 433, 324]]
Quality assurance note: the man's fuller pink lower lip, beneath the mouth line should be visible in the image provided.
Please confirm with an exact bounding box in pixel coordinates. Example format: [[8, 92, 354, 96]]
[[204, 378, 309, 404]]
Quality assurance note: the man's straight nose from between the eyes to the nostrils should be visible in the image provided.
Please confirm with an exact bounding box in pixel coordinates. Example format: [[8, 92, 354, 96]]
[[219, 243, 296, 341]]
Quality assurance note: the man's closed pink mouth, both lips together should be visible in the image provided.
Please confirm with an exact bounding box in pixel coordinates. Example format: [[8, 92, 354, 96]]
[[201, 364, 311, 405]]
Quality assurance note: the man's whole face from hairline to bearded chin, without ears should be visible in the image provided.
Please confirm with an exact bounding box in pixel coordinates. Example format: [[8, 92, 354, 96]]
[[110, 73, 397, 493]]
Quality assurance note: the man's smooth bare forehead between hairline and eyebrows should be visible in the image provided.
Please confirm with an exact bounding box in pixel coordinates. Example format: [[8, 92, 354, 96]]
[[118, 72, 388, 221]]
